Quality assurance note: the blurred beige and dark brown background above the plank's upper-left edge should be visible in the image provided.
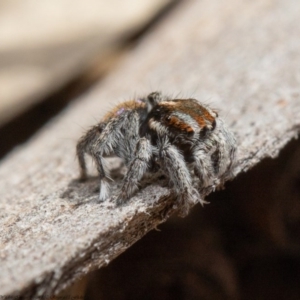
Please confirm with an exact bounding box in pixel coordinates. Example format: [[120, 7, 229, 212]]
[[0, 0, 179, 158]]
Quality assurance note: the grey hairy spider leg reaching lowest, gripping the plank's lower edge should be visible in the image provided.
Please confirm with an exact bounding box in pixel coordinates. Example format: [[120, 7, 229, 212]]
[[158, 139, 205, 217]]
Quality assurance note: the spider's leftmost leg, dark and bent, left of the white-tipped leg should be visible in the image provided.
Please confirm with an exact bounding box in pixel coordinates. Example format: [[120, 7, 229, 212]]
[[76, 125, 101, 180]]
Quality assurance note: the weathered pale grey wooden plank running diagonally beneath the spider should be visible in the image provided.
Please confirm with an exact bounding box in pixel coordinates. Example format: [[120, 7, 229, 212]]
[[0, 0, 300, 299]]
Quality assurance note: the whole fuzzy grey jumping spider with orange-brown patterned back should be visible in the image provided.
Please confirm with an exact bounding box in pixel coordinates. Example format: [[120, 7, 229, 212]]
[[77, 92, 236, 216]]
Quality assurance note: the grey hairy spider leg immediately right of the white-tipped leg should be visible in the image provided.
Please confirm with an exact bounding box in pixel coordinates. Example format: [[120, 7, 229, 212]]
[[117, 137, 152, 204]]
